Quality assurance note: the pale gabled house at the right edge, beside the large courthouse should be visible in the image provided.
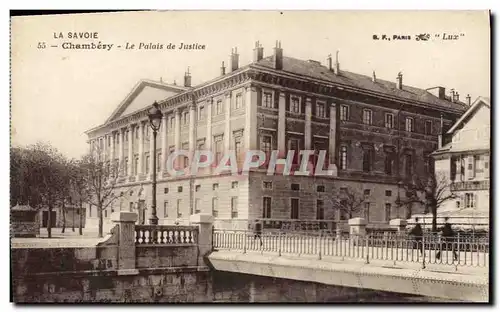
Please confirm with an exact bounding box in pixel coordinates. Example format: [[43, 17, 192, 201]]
[[433, 97, 491, 226]]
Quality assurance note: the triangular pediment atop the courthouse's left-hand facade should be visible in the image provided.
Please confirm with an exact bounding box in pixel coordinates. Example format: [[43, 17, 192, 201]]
[[106, 80, 187, 123]]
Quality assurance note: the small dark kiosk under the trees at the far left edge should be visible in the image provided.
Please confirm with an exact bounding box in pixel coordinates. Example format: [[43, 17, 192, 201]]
[[10, 204, 40, 237]]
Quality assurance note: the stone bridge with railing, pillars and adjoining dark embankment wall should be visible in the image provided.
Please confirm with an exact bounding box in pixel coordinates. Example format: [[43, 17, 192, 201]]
[[12, 211, 489, 302]]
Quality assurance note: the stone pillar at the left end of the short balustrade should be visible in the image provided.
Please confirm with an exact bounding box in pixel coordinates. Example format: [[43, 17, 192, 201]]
[[111, 211, 139, 275]]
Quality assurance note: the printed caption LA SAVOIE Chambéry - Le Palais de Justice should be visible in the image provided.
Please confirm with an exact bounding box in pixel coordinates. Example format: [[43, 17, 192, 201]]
[[54, 32, 206, 51]]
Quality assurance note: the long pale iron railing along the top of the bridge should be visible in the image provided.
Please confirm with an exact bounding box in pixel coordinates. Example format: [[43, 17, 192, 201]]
[[213, 230, 489, 268]]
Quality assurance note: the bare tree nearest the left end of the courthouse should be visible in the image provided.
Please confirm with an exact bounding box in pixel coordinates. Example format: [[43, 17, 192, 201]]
[[80, 146, 131, 237]]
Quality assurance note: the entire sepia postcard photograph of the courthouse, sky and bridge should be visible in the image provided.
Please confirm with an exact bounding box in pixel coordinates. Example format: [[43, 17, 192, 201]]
[[9, 10, 493, 304]]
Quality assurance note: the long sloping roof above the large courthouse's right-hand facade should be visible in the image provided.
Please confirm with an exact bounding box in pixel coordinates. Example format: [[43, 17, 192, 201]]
[[254, 56, 467, 110]]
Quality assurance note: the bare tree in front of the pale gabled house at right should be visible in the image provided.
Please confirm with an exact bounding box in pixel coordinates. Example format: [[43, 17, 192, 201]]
[[396, 173, 458, 232]]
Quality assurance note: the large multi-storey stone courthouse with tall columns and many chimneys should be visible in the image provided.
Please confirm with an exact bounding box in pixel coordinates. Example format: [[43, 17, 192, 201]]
[[87, 42, 466, 232]]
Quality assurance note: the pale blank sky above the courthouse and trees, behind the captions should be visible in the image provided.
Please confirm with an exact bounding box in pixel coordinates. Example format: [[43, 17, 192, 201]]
[[11, 11, 490, 157]]
